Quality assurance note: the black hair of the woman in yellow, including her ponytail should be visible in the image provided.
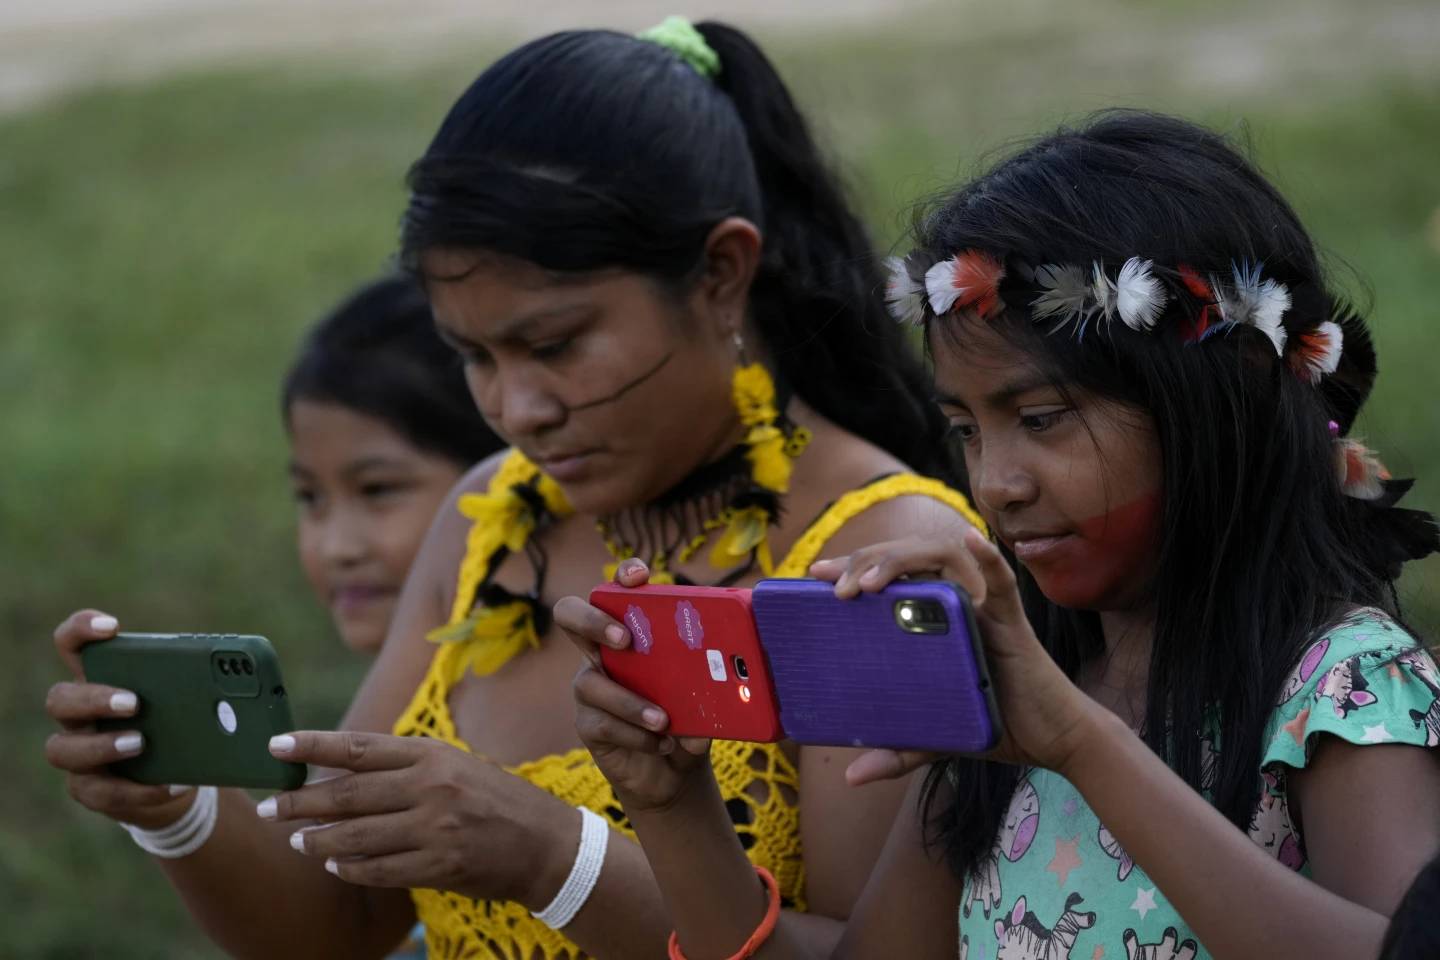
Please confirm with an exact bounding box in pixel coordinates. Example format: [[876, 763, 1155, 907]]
[[400, 22, 945, 472]]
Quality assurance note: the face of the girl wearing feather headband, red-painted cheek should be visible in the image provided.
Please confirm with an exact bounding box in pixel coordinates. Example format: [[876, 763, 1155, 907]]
[[930, 320, 1161, 610]]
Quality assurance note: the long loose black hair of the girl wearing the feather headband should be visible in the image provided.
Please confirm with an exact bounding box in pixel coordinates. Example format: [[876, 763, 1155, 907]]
[[917, 111, 1437, 877]]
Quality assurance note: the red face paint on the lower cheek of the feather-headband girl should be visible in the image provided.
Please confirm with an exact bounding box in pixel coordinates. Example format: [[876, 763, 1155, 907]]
[[1024, 492, 1161, 610]]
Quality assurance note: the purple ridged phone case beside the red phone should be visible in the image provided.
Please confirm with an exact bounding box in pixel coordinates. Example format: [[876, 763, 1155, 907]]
[[750, 580, 1001, 753]]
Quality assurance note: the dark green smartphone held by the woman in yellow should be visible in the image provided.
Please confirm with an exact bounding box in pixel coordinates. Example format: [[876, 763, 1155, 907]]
[[81, 633, 305, 790]]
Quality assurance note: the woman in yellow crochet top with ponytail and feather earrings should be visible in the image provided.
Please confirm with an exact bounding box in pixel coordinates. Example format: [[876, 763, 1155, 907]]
[[49, 20, 971, 960]]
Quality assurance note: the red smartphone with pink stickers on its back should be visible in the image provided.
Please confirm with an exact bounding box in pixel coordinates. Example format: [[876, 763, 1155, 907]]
[[590, 583, 782, 743]]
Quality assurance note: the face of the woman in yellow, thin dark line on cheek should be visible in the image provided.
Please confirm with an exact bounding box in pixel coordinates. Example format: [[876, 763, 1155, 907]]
[[425, 252, 747, 514]]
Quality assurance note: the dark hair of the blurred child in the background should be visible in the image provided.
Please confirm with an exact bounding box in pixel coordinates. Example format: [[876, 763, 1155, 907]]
[[281, 275, 503, 468]]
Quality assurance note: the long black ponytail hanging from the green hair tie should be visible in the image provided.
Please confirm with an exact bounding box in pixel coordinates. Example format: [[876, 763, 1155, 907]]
[[697, 22, 948, 472]]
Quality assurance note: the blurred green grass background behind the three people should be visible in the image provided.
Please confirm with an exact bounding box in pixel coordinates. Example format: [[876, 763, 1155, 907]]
[[0, 0, 1440, 957]]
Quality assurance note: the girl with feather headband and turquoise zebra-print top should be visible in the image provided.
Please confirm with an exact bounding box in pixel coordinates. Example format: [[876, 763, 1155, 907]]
[[557, 112, 1440, 960]]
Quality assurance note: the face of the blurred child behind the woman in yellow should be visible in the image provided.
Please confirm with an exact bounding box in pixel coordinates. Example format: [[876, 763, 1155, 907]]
[[289, 400, 464, 653]]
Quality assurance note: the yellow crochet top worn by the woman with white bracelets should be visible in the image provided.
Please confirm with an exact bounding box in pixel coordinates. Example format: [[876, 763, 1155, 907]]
[[395, 463, 984, 960]]
